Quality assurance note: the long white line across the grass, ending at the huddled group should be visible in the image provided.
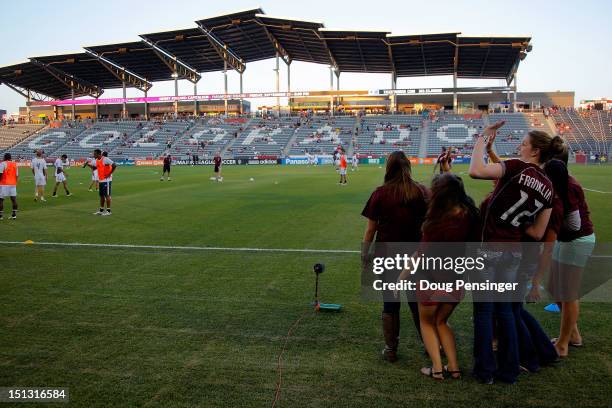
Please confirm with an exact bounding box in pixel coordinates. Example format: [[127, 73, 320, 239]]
[[0, 241, 361, 254]]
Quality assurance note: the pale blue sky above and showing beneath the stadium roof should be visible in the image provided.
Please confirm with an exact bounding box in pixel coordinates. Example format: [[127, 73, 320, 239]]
[[0, 0, 612, 113]]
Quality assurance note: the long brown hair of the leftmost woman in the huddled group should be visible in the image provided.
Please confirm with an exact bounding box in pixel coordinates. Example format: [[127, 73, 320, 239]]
[[384, 151, 423, 203]]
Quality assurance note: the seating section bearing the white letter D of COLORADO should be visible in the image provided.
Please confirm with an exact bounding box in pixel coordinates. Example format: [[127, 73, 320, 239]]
[[354, 115, 423, 156]]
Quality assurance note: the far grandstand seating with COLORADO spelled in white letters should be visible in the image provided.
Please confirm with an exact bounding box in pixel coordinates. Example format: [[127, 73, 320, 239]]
[[0, 110, 612, 160]]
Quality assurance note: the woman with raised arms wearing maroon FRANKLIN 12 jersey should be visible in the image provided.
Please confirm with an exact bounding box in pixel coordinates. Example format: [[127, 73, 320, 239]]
[[469, 121, 565, 384]]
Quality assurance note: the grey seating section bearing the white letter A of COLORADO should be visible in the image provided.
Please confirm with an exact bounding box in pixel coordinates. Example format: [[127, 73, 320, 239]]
[[289, 116, 356, 155]]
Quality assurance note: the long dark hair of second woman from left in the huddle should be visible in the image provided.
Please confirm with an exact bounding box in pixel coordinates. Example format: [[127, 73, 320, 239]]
[[422, 173, 479, 236]]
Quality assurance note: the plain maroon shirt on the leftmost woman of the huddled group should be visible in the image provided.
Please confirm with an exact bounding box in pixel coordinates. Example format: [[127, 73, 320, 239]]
[[361, 184, 429, 242]]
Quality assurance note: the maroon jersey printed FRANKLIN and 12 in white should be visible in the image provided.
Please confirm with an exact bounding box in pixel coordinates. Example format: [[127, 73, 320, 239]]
[[481, 159, 554, 242]]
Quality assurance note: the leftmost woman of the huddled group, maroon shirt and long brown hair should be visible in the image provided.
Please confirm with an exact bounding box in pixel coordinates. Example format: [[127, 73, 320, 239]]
[[361, 151, 429, 362]]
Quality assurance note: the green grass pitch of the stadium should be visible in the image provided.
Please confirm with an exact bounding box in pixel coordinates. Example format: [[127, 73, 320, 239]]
[[0, 165, 612, 408]]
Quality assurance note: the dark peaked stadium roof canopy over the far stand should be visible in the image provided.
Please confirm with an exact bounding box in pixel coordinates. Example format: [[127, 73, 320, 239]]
[[0, 8, 531, 98]]
